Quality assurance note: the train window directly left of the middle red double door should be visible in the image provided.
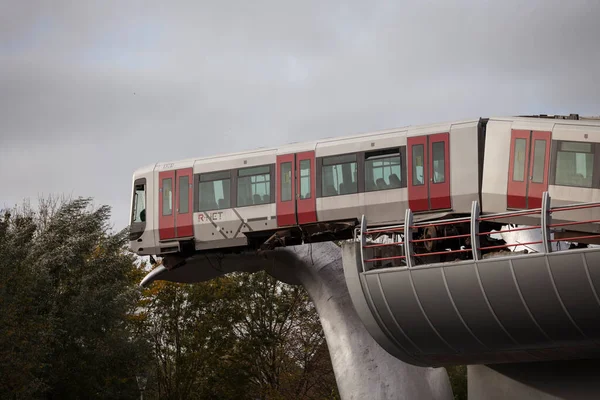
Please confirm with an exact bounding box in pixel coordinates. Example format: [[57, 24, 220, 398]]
[[237, 165, 271, 207]]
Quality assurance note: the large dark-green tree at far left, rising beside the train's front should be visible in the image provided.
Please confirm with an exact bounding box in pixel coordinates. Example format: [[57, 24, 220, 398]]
[[0, 199, 147, 399]]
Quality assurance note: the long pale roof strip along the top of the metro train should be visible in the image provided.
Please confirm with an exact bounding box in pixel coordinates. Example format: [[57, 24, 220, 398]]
[[134, 114, 600, 175]]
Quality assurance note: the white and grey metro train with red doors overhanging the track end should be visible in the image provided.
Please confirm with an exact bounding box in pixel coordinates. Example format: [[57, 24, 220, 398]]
[[130, 114, 600, 268]]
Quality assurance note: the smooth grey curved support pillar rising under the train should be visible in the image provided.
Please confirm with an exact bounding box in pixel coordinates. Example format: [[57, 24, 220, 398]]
[[279, 243, 453, 400]]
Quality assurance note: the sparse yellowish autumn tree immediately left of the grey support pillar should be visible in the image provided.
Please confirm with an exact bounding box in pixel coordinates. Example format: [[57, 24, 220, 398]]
[[234, 272, 337, 399]]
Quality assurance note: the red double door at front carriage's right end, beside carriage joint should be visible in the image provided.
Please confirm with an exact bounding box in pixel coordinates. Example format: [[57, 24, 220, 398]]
[[407, 132, 451, 212]]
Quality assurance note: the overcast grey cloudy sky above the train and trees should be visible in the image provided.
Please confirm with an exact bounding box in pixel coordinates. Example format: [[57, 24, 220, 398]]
[[0, 0, 600, 229]]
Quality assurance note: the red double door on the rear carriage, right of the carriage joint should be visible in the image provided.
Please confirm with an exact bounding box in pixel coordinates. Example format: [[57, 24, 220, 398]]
[[506, 129, 552, 209]]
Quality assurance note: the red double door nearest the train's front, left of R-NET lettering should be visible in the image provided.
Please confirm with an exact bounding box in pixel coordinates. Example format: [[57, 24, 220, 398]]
[[158, 168, 194, 240]]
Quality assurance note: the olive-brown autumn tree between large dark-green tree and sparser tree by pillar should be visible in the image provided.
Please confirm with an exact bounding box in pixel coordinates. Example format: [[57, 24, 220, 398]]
[[132, 277, 254, 399]]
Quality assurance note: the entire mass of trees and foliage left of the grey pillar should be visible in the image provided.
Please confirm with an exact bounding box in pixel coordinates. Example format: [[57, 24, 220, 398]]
[[0, 195, 339, 399]]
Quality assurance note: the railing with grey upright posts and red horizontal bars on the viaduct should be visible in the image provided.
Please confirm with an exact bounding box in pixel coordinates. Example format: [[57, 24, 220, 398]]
[[355, 192, 600, 272]]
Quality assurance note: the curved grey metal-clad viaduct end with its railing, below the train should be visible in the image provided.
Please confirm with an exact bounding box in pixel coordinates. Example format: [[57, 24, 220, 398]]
[[343, 193, 600, 366]]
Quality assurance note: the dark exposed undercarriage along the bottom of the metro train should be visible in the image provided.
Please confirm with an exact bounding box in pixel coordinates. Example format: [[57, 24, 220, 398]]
[[157, 215, 588, 269]]
